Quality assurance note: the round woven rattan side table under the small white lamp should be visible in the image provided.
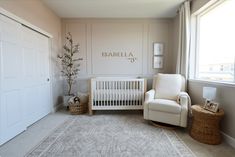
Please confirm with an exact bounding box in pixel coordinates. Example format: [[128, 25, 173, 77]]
[[190, 105, 224, 144]]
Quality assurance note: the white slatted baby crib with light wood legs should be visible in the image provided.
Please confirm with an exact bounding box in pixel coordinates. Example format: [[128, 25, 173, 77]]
[[89, 77, 146, 114]]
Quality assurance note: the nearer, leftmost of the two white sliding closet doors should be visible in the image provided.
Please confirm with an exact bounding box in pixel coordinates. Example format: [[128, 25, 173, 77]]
[[0, 16, 26, 144]]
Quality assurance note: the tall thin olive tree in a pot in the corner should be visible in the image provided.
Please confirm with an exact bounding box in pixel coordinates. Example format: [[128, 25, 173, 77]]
[[58, 32, 82, 106]]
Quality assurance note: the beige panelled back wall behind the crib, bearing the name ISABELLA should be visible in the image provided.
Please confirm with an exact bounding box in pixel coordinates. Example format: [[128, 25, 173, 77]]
[[62, 19, 174, 91]]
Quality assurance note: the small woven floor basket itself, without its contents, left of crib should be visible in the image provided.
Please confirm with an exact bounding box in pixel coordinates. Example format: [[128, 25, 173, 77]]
[[69, 103, 88, 115]]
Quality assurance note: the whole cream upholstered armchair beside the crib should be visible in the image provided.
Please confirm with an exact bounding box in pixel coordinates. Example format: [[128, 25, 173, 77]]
[[144, 74, 191, 127]]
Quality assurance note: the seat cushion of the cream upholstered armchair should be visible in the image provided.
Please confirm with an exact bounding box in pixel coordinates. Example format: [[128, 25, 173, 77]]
[[148, 99, 181, 114]]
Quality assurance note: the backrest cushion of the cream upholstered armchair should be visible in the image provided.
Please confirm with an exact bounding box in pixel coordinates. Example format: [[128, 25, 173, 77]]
[[153, 74, 182, 101]]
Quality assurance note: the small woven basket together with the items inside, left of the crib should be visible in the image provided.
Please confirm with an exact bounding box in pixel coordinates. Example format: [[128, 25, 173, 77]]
[[69, 97, 88, 114]]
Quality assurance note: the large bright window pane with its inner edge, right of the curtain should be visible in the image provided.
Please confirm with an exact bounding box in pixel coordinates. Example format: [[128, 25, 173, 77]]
[[195, 0, 235, 83]]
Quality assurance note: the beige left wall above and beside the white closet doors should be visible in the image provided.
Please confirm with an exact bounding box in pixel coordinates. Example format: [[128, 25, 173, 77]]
[[0, 0, 63, 110]]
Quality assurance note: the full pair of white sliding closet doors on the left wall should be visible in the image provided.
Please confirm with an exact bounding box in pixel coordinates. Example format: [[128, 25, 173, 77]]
[[0, 15, 52, 145]]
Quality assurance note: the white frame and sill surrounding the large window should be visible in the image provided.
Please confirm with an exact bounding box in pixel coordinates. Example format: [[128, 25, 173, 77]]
[[189, 0, 235, 86]]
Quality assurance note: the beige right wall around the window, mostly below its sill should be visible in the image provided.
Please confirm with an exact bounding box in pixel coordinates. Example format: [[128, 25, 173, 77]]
[[188, 0, 235, 139]]
